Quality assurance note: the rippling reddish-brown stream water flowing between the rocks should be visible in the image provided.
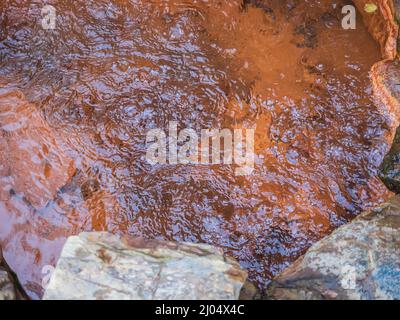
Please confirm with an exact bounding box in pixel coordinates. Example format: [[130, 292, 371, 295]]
[[0, 0, 390, 298]]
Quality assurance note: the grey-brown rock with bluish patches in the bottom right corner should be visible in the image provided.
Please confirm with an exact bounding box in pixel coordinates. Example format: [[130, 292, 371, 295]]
[[267, 196, 400, 300]]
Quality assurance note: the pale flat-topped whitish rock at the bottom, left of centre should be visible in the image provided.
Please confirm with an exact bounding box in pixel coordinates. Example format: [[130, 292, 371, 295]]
[[43, 232, 247, 300]]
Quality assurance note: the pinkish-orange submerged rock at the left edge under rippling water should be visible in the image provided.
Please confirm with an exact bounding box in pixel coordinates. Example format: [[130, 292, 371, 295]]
[[0, 89, 75, 209]]
